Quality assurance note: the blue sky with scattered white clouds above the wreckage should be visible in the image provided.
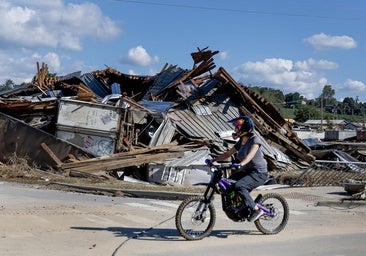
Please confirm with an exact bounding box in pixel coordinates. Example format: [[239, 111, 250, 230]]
[[0, 0, 366, 102]]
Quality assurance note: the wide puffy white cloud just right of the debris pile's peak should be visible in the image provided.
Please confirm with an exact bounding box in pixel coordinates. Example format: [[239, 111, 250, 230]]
[[234, 58, 338, 99]]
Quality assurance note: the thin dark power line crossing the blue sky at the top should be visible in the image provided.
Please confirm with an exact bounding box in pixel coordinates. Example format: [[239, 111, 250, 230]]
[[114, 0, 359, 20]]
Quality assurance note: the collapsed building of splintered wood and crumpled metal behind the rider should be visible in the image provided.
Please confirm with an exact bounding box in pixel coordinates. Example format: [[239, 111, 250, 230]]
[[0, 48, 364, 185]]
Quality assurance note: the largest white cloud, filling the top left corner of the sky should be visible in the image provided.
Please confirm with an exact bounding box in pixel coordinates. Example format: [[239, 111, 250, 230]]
[[0, 0, 120, 51]]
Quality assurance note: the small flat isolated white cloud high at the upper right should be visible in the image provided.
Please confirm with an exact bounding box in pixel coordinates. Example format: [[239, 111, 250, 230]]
[[304, 33, 357, 50]]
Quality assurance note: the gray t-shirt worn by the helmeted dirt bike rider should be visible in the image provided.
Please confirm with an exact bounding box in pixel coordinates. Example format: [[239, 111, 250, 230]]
[[234, 135, 268, 172]]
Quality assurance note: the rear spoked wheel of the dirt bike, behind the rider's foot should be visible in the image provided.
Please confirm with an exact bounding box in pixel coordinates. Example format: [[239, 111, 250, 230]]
[[254, 193, 290, 235]]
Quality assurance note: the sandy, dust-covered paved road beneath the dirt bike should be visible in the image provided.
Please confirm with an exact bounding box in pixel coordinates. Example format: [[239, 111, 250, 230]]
[[0, 183, 366, 256]]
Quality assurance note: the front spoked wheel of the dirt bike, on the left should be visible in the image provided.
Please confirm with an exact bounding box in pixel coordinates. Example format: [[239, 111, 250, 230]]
[[175, 196, 216, 240]]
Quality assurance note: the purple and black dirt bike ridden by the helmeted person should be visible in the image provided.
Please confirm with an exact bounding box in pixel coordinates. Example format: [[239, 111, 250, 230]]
[[175, 163, 289, 240]]
